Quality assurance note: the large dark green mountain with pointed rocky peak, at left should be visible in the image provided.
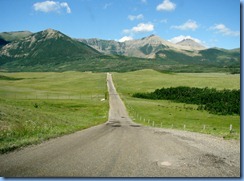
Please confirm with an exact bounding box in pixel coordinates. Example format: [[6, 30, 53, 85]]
[[0, 29, 100, 64]]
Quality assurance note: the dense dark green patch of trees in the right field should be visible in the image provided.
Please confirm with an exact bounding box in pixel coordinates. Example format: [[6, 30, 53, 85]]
[[133, 86, 240, 115]]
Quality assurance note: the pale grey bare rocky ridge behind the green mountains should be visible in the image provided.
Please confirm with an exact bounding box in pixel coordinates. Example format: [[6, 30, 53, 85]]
[[78, 35, 206, 58]]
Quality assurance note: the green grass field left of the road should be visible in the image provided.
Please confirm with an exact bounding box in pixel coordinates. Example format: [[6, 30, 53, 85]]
[[0, 72, 108, 153]]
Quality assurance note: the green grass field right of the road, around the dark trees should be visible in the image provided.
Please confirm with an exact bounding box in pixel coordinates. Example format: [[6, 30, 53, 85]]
[[113, 70, 240, 139]]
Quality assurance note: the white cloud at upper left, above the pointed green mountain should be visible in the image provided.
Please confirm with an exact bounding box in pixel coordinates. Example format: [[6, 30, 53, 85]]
[[33, 1, 71, 13]]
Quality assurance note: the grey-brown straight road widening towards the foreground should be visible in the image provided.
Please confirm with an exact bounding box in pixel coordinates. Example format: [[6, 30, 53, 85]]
[[0, 74, 240, 177]]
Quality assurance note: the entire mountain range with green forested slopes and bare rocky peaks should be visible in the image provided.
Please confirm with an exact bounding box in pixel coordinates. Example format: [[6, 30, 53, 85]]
[[0, 29, 240, 71]]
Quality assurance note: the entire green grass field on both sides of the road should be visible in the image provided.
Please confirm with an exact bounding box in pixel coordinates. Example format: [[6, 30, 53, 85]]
[[0, 70, 240, 153]]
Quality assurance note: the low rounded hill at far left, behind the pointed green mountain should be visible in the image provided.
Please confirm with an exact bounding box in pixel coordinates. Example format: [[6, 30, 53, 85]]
[[0, 31, 32, 42]]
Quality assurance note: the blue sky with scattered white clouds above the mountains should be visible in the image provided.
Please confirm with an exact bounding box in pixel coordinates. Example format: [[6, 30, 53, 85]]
[[0, 0, 240, 49]]
